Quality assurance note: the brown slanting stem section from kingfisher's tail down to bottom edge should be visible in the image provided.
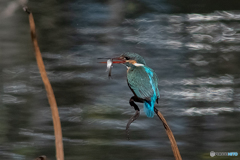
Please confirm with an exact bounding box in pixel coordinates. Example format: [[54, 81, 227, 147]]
[[154, 107, 182, 160]]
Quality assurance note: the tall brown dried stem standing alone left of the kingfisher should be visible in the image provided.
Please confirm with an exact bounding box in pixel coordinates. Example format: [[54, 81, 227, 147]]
[[23, 7, 64, 160]]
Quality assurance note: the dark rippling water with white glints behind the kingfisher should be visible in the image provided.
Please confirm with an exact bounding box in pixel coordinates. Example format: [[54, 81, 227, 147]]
[[0, 0, 240, 160]]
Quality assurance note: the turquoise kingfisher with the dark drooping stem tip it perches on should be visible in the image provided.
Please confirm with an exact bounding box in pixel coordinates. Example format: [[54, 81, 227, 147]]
[[99, 52, 160, 139]]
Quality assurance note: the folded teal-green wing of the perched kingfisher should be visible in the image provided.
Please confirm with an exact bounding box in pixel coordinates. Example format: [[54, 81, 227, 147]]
[[127, 67, 159, 100]]
